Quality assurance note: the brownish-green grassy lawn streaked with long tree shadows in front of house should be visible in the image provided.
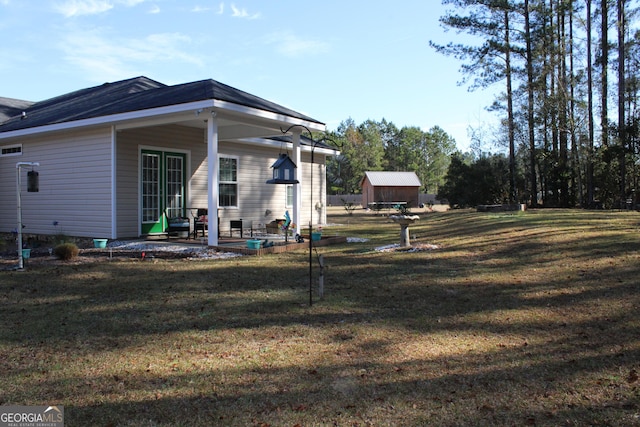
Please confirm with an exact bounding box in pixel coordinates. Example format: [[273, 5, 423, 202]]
[[0, 208, 640, 426]]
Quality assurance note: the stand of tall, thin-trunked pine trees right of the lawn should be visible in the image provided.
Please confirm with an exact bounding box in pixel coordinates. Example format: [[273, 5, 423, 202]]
[[430, 0, 640, 207]]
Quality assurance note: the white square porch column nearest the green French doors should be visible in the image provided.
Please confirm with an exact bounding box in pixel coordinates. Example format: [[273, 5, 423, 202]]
[[207, 115, 219, 246]]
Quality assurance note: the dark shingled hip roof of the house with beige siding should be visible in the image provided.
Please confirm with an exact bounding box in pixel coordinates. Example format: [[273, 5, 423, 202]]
[[0, 77, 322, 133]]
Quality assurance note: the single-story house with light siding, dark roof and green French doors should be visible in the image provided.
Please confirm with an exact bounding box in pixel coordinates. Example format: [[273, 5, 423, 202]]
[[0, 77, 337, 246]]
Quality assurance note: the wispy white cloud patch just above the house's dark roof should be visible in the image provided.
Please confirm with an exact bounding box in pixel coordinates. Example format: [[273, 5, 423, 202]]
[[60, 29, 203, 82]]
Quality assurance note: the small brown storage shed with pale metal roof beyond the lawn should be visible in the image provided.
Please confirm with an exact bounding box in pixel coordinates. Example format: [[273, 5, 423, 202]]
[[360, 171, 422, 208]]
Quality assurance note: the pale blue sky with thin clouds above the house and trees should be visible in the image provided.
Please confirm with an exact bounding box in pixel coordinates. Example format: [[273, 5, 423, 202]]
[[0, 0, 502, 150]]
